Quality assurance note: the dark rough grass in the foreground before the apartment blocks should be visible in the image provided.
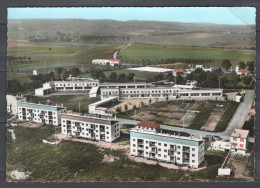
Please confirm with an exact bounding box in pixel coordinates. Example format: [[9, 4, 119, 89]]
[[6, 126, 232, 182]]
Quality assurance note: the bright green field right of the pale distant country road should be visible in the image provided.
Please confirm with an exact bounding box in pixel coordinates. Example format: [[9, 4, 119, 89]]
[[119, 44, 255, 67]]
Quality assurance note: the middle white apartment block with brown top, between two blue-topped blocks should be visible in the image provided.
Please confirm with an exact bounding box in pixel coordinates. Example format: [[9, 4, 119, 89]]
[[61, 114, 120, 142]]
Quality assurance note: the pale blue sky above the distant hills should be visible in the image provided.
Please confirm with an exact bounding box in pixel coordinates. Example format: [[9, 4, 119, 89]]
[[8, 7, 255, 25]]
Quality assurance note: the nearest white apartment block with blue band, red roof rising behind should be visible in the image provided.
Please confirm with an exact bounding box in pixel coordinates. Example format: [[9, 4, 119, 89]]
[[130, 121, 205, 168]]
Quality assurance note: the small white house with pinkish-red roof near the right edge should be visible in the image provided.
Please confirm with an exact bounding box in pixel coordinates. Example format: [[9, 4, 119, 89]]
[[230, 129, 249, 155]]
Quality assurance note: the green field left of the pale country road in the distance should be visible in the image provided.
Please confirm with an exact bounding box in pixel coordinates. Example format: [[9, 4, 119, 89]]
[[8, 45, 121, 70]]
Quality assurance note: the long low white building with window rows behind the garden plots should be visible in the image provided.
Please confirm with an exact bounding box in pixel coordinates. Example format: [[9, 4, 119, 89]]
[[101, 87, 223, 100]]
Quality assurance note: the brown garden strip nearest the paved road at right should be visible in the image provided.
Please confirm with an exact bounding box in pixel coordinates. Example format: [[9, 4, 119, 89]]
[[201, 107, 226, 131]]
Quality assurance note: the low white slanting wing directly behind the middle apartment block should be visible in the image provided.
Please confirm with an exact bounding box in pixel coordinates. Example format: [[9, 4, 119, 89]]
[[88, 97, 118, 116]]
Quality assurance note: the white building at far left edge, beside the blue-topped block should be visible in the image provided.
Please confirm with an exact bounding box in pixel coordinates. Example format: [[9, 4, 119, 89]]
[[6, 95, 26, 115]]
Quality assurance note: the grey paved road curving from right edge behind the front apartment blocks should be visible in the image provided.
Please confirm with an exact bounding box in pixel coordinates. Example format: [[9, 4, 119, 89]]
[[117, 90, 255, 140]]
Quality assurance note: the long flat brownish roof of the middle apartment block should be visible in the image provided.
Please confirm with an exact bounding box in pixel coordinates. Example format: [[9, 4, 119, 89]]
[[61, 114, 118, 125]]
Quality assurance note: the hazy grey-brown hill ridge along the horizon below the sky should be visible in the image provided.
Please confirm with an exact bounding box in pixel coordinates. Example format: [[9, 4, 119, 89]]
[[8, 19, 255, 40]]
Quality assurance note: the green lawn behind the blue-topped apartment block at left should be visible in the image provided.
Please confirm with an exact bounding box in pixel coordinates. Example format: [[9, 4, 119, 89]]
[[31, 95, 100, 113]]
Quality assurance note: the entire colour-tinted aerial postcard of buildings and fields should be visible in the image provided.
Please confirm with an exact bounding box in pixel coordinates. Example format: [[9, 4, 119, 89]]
[[6, 7, 256, 182]]
